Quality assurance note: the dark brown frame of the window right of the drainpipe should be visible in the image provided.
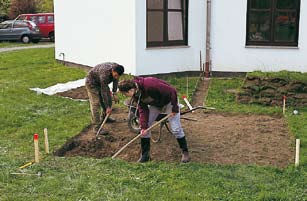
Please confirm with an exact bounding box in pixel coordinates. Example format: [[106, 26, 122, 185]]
[[245, 0, 301, 47]]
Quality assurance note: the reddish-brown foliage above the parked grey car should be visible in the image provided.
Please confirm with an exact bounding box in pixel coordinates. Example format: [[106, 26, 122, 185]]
[[9, 0, 36, 19]]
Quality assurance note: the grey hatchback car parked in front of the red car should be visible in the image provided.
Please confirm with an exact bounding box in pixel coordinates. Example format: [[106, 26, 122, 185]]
[[0, 20, 42, 43]]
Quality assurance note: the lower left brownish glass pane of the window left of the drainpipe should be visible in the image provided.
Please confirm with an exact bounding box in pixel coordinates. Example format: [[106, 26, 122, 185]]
[[147, 11, 163, 42]]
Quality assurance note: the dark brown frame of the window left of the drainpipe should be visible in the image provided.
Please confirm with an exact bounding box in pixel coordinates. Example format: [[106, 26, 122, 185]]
[[146, 0, 189, 48]]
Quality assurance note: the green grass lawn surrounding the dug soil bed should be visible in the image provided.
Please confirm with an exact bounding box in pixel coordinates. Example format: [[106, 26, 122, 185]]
[[0, 48, 307, 201]]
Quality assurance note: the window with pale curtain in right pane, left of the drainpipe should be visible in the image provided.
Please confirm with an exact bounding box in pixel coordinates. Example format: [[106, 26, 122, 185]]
[[147, 0, 188, 47]]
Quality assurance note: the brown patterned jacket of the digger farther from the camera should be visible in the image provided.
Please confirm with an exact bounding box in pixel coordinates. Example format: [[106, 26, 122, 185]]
[[86, 62, 118, 107]]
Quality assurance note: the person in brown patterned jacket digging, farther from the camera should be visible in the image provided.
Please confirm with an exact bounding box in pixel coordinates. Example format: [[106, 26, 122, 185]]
[[85, 62, 124, 135]]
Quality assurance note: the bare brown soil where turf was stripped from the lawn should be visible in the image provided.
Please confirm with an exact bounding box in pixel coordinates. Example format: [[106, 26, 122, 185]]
[[55, 81, 294, 168]]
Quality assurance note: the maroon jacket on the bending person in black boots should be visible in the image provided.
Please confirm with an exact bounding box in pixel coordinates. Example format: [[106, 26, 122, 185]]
[[134, 77, 179, 129]]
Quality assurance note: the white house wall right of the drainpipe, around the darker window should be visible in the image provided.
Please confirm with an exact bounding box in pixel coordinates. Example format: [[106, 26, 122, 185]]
[[211, 0, 307, 72]]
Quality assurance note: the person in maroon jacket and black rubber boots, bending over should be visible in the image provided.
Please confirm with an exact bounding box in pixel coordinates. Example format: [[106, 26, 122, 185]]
[[118, 77, 190, 163]]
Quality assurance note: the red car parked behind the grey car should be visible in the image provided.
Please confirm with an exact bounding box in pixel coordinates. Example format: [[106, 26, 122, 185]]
[[16, 13, 54, 42]]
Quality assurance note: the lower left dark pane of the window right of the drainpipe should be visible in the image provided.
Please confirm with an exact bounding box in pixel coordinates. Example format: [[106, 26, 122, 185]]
[[248, 11, 271, 41]]
